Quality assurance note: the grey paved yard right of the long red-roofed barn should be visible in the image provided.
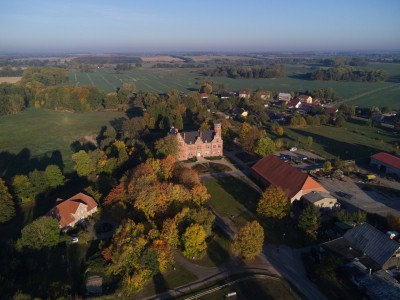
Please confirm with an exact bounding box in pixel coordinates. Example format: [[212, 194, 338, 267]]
[[317, 176, 400, 217]]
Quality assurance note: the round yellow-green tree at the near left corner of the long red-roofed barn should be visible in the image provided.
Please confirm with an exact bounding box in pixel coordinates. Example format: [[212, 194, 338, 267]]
[[257, 185, 290, 220]]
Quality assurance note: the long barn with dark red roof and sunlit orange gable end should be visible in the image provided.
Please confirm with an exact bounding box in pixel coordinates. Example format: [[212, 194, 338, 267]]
[[252, 155, 329, 202]]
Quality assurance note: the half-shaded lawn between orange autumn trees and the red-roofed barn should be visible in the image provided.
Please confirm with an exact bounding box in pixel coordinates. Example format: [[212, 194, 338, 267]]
[[204, 177, 260, 227]]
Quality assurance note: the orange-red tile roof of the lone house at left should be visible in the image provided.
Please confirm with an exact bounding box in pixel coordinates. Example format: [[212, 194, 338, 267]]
[[49, 193, 97, 228]]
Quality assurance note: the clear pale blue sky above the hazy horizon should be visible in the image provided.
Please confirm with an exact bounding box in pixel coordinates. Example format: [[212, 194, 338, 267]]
[[0, 0, 400, 53]]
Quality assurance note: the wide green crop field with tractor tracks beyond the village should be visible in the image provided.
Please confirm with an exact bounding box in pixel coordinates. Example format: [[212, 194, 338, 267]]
[[69, 63, 400, 109]]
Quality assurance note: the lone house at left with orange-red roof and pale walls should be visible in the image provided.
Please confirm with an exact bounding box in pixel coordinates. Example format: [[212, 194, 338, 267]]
[[48, 193, 97, 229]]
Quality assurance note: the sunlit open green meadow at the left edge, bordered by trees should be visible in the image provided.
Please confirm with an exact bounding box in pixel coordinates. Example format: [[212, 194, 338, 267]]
[[0, 108, 125, 176]]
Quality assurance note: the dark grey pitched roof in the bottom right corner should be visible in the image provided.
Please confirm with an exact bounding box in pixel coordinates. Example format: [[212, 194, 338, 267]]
[[343, 223, 400, 267]]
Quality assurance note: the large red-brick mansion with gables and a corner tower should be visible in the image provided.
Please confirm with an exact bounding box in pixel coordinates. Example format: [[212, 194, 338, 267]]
[[170, 123, 223, 161]]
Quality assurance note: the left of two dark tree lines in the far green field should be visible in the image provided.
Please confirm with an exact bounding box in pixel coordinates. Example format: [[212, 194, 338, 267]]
[[202, 65, 285, 79]]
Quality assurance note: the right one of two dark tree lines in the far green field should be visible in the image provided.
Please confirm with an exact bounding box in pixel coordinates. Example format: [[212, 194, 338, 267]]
[[306, 65, 387, 82]]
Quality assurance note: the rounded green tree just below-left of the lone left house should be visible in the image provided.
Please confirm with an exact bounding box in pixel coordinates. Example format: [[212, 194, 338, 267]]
[[17, 217, 60, 250]]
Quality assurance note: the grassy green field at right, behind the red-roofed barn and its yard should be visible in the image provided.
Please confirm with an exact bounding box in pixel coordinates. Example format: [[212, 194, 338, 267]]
[[285, 122, 399, 159]]
